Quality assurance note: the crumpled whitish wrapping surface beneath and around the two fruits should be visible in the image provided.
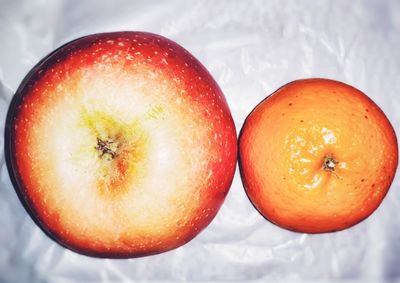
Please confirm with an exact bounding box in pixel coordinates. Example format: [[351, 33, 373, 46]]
[[0, 0, 400, 283]]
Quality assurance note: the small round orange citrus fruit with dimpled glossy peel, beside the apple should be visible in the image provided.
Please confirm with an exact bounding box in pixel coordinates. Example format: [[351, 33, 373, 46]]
[[239, 79, 398, 233]]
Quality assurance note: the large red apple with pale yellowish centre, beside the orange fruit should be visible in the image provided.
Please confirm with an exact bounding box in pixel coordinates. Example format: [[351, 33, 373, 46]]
[[6, 32, 237, 258]]
